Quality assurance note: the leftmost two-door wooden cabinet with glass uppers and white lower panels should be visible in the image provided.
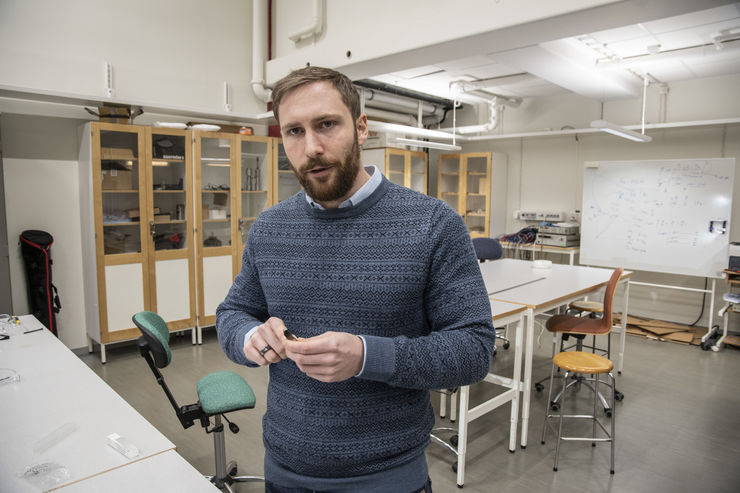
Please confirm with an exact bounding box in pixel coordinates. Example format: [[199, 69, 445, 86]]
[[79, 122, 195, 361]]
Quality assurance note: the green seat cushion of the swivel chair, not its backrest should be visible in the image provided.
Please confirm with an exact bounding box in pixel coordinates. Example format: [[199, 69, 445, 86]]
[[198, 371, 256, 414]]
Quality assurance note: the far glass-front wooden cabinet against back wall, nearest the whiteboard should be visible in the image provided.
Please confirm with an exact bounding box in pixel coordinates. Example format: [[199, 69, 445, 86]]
[[437, 152, 491, 237]]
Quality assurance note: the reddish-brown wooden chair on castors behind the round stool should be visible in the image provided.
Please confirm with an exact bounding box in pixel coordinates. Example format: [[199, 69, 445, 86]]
[[535, 268, 624, 416]]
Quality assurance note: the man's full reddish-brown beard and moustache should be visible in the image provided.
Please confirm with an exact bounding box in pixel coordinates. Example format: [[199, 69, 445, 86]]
[[291, 132, 360, 202]]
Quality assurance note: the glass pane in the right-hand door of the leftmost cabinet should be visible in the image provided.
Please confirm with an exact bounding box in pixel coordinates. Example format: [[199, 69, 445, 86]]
[[149, 132, 189, 251]]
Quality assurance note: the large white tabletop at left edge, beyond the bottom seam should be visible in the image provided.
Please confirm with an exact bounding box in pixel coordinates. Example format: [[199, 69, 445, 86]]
[[0, 316, 207, 493]]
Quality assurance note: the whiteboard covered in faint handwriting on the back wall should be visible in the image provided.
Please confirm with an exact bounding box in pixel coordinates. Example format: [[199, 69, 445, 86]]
[[580, 158, 735, 278]]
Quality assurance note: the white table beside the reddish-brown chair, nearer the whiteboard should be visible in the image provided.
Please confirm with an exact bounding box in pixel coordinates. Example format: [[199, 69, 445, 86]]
[[481, 259, 631, 448]]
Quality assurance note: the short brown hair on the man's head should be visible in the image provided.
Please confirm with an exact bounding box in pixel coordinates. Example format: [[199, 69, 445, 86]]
[[272, 66, 360, 125]]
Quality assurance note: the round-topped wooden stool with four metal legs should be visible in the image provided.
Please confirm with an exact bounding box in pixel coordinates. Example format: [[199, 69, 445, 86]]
[[542, 351, 616, 474]]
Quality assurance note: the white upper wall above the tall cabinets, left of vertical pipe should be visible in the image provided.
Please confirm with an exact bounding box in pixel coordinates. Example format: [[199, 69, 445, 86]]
[[0, 0, 265, 118]]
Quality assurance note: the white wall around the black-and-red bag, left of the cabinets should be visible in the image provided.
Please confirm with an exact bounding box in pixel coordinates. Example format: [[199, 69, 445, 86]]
[[3, 158, 87, 348]]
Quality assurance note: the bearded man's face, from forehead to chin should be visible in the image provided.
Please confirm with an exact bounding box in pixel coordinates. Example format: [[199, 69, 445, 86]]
[[280, 82, 367, 205]]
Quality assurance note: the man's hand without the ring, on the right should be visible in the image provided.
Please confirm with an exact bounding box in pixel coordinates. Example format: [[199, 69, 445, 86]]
[[284, 332, 365, 382]]
